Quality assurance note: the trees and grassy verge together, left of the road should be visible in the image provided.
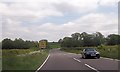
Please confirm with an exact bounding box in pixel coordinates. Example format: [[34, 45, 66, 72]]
[[2, 38, 50, 72]]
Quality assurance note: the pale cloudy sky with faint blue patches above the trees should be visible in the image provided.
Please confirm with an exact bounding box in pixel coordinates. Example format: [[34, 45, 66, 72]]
[[0, 0, 119, 41]]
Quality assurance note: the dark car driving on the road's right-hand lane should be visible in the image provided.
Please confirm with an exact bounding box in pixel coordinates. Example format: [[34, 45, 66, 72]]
[[81, 48, 100, 59]]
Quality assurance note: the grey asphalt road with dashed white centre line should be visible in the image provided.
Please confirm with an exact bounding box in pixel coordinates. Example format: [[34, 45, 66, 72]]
[[37, 49, 119, 72]]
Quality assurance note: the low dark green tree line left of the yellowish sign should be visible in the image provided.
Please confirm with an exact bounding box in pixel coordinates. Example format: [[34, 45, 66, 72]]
[[2, 38, 39, 49]]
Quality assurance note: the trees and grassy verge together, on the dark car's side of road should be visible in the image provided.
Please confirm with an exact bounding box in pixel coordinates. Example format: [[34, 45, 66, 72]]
[[58, 32, 120, 59]]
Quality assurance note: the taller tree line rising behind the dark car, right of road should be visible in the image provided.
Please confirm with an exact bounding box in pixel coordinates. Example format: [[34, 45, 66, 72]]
[[58, 32, 120, 47]]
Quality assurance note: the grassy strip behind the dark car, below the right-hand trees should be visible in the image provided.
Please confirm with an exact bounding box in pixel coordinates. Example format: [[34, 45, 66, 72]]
[[61, 45, 120, 59]]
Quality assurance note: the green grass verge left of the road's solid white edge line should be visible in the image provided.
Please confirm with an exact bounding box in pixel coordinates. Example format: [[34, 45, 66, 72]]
[[2, 49, 49, 70]]
